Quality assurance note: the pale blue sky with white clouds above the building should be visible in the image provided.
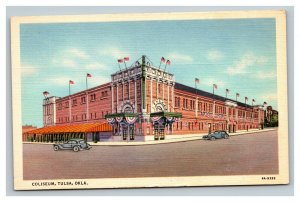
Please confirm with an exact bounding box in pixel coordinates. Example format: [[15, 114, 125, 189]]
[[21, 19, 277, 126]]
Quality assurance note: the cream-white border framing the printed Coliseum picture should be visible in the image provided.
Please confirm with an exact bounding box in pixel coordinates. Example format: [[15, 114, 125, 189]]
[[11, 10, 289, 190]]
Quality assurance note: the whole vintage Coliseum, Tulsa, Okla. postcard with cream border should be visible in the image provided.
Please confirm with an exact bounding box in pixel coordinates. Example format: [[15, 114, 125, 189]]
[[11, 10, 289, 190]]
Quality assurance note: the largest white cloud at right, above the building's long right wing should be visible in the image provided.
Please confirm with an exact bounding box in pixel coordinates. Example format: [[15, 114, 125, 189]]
[[227, 53, 268, 75]]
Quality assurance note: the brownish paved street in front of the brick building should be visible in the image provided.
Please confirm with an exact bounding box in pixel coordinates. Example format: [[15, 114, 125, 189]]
[[23, 130, 278, 180]]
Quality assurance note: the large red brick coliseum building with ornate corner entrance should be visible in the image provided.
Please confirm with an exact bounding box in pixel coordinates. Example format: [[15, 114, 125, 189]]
[[43, 56, 264, 141]]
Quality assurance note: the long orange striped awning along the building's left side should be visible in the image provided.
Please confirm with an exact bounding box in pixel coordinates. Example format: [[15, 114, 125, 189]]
[[24, 123, 112, 134]]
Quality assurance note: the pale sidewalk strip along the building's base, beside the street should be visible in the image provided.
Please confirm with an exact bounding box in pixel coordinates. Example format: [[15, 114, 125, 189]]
[[89, 128, 277, 146]]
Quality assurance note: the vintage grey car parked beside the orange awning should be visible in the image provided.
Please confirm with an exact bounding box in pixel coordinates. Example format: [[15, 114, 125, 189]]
[[53, 139, 91, 152]]
